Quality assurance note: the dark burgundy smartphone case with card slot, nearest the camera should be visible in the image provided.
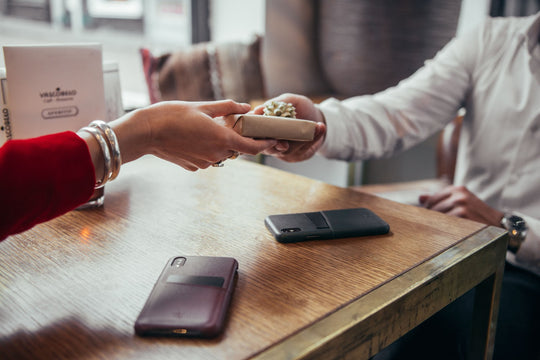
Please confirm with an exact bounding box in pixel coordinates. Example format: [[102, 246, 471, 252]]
[[135, 256, 238, 337]]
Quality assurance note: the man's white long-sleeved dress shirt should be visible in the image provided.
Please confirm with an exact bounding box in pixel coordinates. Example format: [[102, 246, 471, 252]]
[[319, 13, 540, 275]]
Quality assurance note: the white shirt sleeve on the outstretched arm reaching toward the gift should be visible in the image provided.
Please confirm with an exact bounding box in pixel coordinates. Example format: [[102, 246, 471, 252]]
[[319, 20, 481, 161]]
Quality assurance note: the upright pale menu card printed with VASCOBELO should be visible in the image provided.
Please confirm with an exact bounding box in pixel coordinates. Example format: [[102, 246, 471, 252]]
[[3, 44, 107, 139]]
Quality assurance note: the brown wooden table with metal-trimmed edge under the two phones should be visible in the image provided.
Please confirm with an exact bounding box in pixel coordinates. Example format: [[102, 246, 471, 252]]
[[0, 157, 507, 359]]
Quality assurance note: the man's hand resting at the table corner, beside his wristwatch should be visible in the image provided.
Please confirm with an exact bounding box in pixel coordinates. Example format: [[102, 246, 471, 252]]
[[418, 185, 504, 227]]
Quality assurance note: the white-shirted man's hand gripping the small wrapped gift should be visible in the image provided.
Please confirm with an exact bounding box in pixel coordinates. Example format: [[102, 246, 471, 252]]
[[254, 94, 326, 162]]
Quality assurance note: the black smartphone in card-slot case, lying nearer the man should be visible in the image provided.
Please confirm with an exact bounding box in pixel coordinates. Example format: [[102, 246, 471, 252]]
[[264, 208, 390, 243]]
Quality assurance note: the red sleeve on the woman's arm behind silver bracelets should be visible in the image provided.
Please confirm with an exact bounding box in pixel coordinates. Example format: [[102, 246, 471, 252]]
[[0, 131, 95, 240]]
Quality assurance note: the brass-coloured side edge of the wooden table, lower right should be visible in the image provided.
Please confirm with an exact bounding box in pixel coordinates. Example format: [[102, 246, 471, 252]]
[[252, 226, 508, 359]]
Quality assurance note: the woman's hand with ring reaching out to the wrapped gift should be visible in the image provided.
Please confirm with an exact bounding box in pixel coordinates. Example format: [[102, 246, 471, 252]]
[[110, 100, 277, 171]]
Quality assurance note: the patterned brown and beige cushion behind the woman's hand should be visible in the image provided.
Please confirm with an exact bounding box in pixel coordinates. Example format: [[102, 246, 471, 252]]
[[140, 36, 265, 103]]
